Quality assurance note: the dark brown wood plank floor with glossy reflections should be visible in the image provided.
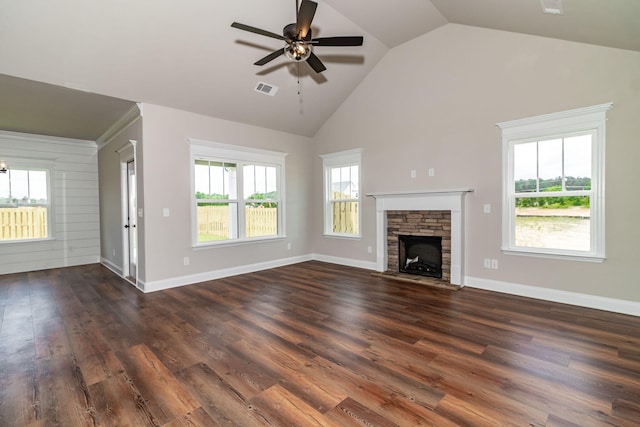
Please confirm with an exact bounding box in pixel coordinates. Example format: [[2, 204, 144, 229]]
[[0, 262, 640, 427]]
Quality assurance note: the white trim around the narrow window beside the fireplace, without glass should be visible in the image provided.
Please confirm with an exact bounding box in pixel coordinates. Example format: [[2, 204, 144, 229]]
[[320, 148, 362, 239]]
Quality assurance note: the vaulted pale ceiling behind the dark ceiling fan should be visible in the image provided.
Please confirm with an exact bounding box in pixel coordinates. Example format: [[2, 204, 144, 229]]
[[0, 0, 640, 140]]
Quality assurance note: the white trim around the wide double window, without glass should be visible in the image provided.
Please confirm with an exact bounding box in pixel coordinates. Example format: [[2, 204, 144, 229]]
[[187, 138, 288, 248]]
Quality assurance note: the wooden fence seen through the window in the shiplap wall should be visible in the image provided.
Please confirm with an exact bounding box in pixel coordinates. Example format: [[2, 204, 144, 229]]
[[0, 206, 48, 240]]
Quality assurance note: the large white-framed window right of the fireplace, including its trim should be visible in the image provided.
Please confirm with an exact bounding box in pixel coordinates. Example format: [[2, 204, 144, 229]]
[[498, 104, 611, 261]]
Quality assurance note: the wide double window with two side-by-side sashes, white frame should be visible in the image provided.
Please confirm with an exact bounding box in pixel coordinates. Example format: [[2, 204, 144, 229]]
[[190, 140, 286, 246]]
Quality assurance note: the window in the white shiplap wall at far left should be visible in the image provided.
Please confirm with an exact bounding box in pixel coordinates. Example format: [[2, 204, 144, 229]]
[[0, 166, 51, 242]]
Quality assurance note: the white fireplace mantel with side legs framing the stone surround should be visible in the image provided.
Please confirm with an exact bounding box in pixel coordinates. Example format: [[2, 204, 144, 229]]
[[367, 188, 474, 286]]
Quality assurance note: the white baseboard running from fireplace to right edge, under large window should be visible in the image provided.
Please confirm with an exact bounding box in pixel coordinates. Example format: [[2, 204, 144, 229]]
[[464, 276, 640, 316]]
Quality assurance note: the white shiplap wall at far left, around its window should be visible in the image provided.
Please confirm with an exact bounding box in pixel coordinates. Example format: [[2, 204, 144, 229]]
[[0, 132, 100, 274]]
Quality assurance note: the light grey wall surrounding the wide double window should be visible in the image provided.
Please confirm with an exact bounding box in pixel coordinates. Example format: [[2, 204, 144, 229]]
[[138, 104, 311, 291]]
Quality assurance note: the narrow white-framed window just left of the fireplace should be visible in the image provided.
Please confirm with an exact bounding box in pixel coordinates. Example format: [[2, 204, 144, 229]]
[[321, 149, 362, 237]]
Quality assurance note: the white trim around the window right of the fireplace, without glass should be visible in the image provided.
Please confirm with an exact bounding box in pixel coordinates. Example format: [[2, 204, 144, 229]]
[[497, 103, 613, 262]]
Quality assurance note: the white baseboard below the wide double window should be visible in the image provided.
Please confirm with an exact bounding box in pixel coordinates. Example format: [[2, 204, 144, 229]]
[[138, 255, 312, 293]]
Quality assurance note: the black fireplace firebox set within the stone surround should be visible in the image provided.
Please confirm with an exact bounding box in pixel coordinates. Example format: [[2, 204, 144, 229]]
[[398, 235, 442, 279]]
